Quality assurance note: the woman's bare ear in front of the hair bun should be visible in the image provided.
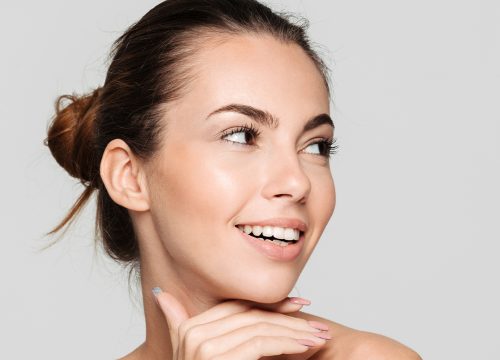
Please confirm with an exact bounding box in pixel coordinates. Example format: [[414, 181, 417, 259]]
[[100, 139, 149, 211]]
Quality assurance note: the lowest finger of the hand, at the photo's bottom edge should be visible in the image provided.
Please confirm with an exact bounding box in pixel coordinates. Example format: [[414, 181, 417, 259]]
[[213, 336, 310, 360]]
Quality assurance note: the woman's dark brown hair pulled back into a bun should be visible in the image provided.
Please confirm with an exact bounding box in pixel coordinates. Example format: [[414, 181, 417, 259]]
[[44, 0, 329, 265]]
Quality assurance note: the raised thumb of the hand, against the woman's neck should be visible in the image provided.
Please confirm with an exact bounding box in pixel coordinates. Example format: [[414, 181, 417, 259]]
[[153, 287, 189, 351]]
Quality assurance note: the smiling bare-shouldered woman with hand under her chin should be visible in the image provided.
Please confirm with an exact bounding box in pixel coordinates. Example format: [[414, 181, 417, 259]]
[[46, 0, 419, 360]]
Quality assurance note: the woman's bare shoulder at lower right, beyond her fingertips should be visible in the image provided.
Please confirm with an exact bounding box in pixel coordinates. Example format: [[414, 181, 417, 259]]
[[293, 311, 422, 360]]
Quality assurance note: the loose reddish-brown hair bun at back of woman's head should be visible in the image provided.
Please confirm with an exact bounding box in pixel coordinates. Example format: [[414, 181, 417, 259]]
[[44, 87, 101, 186]]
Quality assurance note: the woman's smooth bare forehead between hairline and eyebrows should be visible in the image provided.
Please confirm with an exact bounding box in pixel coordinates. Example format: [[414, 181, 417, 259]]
[[178, 34, 329, 117]]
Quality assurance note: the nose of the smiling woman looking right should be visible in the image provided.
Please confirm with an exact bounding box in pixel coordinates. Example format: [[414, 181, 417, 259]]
[[262, 146, 311, 203]]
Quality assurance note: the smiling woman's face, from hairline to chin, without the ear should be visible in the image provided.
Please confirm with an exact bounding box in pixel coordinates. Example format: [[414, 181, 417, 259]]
[[148, 35, 335, 302]]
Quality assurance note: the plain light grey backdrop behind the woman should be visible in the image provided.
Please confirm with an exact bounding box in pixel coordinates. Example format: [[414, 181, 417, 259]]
[[0, 0, 500, 360]]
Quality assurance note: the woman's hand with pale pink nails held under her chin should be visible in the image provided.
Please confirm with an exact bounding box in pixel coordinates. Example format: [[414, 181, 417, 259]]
[[152, 291, 328, 360]]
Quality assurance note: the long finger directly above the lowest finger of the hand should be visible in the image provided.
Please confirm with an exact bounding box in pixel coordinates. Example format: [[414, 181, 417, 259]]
[[192, 323, 326, 359]]
